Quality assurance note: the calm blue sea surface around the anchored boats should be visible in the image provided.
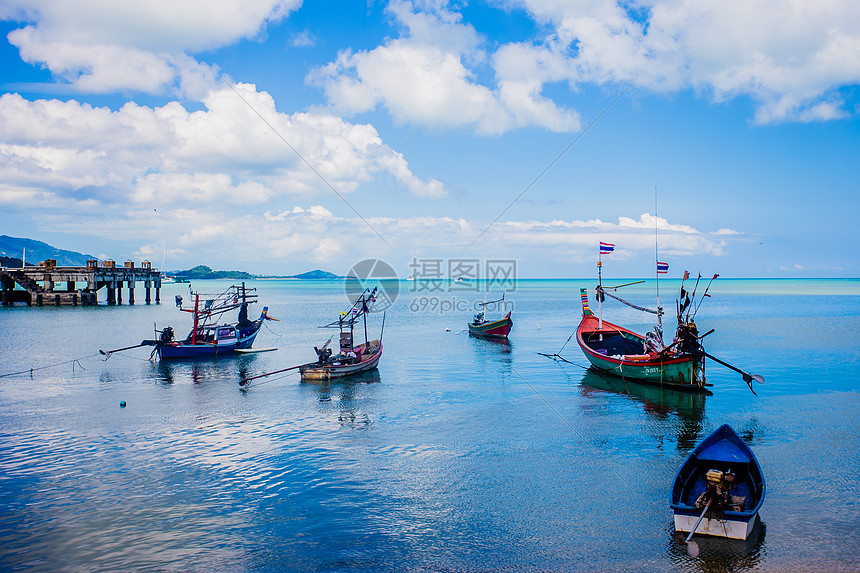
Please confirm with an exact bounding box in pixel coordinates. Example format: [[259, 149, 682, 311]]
[[0, 279, 860, 572]]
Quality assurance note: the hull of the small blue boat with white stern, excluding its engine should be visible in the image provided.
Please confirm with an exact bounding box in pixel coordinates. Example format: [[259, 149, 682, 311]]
[[671, 425, 765, 539]]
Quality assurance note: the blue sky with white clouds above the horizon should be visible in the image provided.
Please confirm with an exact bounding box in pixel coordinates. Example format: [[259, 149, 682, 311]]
[[0, 0, 860, 278]]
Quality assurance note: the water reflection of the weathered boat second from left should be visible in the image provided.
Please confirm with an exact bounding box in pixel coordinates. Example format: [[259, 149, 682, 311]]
[[301, 369, 382, 428]]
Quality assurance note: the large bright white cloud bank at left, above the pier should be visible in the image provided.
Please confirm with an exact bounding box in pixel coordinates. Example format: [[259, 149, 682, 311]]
[[0, 84, 454, 213]]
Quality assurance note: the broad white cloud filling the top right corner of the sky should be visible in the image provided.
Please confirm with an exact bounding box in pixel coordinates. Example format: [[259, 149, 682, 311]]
[[517, 0, 860, 123]]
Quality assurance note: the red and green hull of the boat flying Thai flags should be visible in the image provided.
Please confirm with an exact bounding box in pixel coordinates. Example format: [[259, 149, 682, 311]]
[[576, 314, 708, 392]]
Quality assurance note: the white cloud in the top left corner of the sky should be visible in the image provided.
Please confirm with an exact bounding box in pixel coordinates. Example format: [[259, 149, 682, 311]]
[[0, 0, 301, 99]]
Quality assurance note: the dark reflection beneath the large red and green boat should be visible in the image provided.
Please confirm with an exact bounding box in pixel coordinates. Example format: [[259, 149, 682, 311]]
[[580, 369, 707, 451]]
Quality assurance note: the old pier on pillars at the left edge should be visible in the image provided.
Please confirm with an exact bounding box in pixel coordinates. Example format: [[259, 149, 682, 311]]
[[0, 260, 161, 306]]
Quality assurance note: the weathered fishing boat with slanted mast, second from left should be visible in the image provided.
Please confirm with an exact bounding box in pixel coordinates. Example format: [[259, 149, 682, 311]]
[[298, 288, 385, 380]]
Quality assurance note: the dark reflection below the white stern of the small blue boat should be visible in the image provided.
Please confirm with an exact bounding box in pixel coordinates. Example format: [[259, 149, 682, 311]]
[[666, 517, 767, 573]]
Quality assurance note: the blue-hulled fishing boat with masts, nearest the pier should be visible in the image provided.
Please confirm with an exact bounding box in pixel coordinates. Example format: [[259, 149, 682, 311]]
[[140, 283, 276, 359]]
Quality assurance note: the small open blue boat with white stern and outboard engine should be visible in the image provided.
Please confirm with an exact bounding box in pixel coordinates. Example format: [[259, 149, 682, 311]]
[[671, 424, 765, 540]]
